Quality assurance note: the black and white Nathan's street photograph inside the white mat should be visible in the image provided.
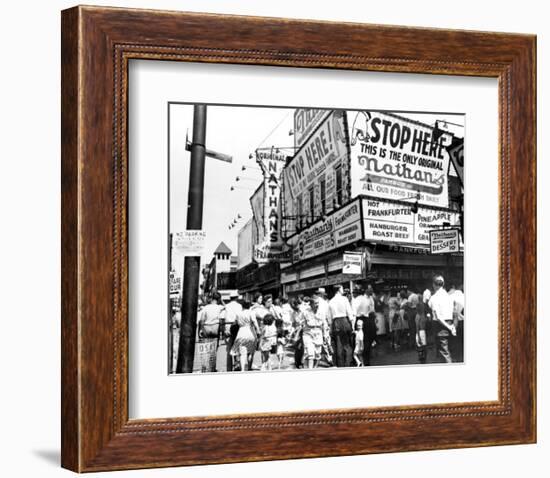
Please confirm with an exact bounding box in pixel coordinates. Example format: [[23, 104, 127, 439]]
[[167, 103, 465, 374]]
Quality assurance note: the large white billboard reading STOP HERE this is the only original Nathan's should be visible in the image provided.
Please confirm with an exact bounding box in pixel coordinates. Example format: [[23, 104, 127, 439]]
[[347, 111, 449, 207]]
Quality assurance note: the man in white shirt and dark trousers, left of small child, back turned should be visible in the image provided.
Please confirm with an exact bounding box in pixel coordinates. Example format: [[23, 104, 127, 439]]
[[328, 286, 353, 367]]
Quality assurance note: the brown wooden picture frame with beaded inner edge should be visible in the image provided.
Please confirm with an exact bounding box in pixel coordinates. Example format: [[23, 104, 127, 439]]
[[61, 7, 536, 472]]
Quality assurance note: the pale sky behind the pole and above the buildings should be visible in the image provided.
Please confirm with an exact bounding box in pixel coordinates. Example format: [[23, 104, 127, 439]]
[[169, 104, 464, 271]]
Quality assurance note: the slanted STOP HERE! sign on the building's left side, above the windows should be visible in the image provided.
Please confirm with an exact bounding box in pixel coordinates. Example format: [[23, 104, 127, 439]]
[[284, 110, 347, 199]]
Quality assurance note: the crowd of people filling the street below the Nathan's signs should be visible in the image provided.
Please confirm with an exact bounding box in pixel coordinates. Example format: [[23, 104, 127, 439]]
[[183, 275, 464, 371]]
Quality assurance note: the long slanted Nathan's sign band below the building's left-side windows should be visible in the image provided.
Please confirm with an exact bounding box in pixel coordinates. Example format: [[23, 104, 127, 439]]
[[292, 200, 361, 262]]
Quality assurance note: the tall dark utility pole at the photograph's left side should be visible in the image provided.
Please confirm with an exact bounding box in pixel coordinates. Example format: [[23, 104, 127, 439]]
[[176, 105, 206, 373]]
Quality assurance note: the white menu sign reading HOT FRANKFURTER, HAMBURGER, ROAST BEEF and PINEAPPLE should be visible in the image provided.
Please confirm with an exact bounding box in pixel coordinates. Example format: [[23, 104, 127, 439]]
[[363, 199, 460, 246]]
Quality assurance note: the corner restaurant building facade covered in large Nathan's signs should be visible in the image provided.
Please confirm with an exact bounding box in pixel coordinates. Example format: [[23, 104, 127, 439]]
[[237, 109, 464, 296]]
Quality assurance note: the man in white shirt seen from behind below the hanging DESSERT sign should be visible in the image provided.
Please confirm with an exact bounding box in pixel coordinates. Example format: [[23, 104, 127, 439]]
[[428, 275, 456, 363]]
